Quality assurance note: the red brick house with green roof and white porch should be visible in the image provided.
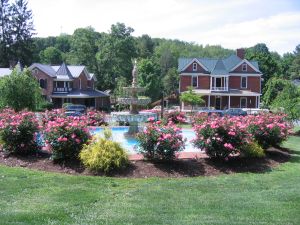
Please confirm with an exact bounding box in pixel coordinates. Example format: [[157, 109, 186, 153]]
[[178, 49, 262, 110]]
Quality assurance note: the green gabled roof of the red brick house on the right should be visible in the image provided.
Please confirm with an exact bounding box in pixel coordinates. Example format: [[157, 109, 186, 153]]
[[178, 55, 261, 75]]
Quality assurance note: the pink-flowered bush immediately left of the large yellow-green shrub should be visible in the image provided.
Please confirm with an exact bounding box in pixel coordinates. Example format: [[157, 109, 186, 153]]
[[44, 116, 91, 160]]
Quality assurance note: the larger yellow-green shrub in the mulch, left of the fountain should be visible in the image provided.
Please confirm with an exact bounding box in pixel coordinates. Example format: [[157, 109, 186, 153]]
[[79, 137, 128, 173]]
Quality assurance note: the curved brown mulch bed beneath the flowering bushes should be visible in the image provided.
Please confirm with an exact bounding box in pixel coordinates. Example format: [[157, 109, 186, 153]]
[[0, 148, 290, 178]]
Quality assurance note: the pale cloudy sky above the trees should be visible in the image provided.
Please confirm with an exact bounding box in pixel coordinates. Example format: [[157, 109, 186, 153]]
[[28, 0, 300, 55]]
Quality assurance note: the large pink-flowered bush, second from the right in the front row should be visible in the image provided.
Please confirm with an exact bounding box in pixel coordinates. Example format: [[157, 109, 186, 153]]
[[193, 116, 249, 159]]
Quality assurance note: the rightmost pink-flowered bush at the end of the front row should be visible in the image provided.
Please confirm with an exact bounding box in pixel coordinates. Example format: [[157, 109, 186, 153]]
[[244, 113, 292, 149]]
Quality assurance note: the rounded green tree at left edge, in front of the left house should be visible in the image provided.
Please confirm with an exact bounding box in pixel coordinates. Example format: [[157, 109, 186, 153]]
[[0, 68, 42, 111]]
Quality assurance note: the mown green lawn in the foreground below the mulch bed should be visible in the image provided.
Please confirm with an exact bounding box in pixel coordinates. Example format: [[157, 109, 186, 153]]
[[0, 136, 300, 225]]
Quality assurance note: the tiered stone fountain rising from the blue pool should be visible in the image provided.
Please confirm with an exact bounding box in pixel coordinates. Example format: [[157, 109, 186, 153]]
[[111, 61, 158, 135]]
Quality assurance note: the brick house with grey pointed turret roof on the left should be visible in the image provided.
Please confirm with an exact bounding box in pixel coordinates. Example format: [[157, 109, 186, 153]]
[[29, 63, 110, 109]]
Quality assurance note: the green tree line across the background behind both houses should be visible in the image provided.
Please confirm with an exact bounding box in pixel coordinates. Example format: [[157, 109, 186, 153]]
[[0, 0, 300, 118]]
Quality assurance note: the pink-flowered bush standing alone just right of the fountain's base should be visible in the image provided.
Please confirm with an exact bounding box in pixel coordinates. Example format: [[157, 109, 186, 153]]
[[137, 119, 185, 160]]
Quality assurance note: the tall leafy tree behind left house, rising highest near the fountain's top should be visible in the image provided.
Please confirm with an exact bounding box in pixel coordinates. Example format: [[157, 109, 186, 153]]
[[97, 23, 137, 89]]
